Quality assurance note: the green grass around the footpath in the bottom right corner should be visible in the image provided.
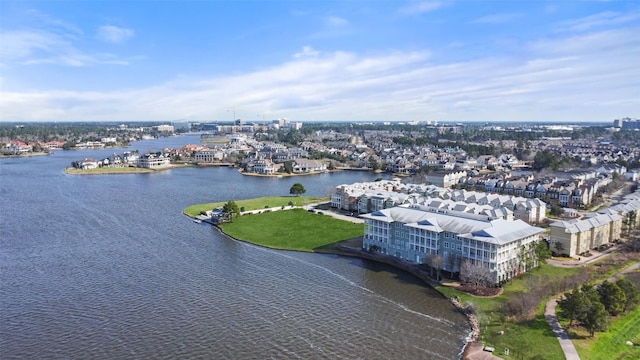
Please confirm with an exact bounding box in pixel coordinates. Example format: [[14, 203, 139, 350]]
[[437, 255, 640, 359]]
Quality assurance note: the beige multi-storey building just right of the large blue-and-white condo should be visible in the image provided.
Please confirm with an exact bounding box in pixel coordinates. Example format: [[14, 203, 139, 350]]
[[549, 214, 622, 257]]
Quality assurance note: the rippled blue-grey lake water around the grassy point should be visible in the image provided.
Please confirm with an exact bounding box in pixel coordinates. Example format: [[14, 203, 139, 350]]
[[0, 135, 469, 359]]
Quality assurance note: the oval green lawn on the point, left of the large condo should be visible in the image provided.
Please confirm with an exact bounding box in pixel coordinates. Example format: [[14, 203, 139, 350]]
[[220, 209, 364, 251]]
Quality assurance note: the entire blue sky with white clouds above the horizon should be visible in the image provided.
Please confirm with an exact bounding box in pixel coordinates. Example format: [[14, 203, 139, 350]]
[[0, 0, 640, 122]]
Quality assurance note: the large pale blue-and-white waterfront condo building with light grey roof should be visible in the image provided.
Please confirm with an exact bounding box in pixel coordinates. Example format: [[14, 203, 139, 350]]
[[361, 206, 544, 284]]
